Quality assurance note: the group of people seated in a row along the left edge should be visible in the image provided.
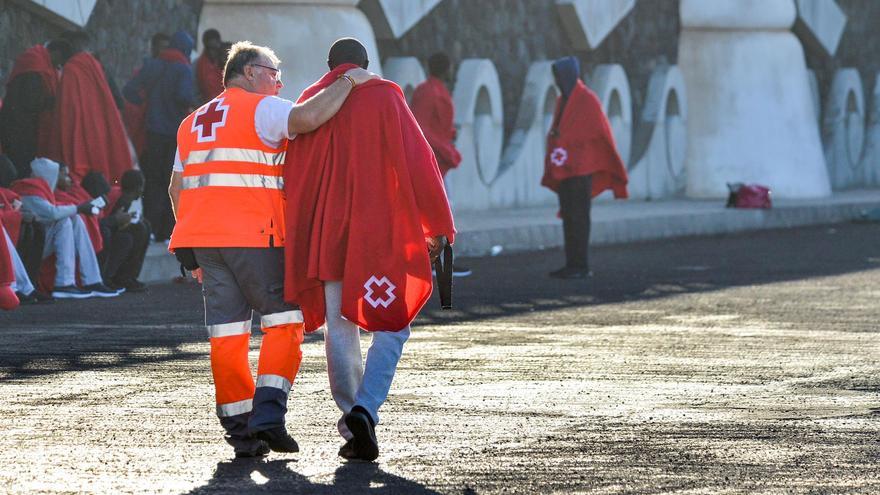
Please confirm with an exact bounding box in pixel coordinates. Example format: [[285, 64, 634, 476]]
[[0, 154, 150, 310]]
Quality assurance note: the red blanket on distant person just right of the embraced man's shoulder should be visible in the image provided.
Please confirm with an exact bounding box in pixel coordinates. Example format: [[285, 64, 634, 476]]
[[410, 77, 461, 177]]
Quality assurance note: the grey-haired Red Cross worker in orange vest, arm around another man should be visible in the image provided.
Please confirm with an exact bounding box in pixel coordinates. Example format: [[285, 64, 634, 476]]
[[169, 41, 375, 457]]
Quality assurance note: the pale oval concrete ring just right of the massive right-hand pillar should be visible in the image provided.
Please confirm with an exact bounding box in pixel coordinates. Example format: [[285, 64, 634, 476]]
[[822, 68, 866, 189]]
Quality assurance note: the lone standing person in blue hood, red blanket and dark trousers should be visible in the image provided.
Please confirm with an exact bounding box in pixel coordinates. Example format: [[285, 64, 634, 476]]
[[541, 57, 628, 279]]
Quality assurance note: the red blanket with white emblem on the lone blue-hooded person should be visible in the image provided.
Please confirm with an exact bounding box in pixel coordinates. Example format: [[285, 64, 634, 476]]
[[541, 81, 628, 198]]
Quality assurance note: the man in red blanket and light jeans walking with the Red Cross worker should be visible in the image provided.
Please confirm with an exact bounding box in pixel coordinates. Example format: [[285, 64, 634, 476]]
[[284, 38, 455, 461]]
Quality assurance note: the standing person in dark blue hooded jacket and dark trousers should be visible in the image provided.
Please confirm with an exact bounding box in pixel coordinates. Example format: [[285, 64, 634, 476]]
[[123, 31, 196, 241]]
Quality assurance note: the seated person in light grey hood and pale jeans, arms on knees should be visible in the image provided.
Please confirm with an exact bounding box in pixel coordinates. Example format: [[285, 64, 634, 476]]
[[12, 158, 120, 299]]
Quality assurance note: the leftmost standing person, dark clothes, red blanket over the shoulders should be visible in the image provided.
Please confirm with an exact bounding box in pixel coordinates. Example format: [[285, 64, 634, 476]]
[[0, 40, 73, 179]]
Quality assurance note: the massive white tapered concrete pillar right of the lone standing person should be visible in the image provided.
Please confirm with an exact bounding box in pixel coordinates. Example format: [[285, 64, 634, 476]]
[[678, 0, 831, 199]]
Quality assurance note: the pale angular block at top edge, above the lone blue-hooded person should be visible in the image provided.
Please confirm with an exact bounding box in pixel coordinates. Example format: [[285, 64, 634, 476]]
[[556, 0, 636, 50]]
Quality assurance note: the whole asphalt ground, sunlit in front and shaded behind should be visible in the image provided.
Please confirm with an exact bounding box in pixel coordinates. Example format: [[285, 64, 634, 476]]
[[0, 224, 880, 494]]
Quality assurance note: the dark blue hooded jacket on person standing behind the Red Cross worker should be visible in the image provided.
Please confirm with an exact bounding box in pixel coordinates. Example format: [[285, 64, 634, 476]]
[[122, 31, 197, 136]]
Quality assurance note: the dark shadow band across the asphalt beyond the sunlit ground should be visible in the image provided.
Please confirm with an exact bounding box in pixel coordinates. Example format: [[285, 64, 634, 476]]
[[0, 224, 880, 380]]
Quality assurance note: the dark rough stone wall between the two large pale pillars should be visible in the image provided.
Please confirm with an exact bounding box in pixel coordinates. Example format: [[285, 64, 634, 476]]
[[379, 0, 679, 136]]
